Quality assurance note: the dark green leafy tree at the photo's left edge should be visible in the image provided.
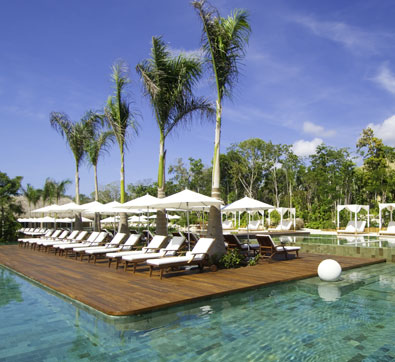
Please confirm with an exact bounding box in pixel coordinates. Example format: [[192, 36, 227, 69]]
[[0, 172, 22, 242]]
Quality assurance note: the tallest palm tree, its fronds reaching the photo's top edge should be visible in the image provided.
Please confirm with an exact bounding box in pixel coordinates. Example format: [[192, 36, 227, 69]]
[[192, 0, 251, 253]]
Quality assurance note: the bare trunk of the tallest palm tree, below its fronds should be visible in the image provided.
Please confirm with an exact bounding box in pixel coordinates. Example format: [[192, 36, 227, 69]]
[[207, 99, 226, 255]]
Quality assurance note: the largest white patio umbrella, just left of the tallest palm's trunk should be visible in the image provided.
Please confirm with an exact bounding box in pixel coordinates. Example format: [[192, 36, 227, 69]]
[[152, 189, 223, 249]]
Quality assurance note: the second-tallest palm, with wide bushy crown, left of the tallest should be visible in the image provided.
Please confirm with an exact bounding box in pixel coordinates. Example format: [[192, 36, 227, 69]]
[[136, 37, 214, 235]]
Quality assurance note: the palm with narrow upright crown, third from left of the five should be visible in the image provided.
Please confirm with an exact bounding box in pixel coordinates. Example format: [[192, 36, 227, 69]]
[[104, 61, 138, 233]]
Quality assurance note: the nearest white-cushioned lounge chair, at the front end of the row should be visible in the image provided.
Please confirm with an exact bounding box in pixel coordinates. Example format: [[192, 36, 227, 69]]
[[147, 238, 215, 279]]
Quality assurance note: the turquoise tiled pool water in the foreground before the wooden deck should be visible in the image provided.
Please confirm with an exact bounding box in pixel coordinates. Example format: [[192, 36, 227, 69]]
[[0, 263, 395, 362]]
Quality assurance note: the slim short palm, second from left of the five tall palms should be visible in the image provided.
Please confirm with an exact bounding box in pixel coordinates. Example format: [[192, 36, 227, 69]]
[[84, 111, 114, 231]]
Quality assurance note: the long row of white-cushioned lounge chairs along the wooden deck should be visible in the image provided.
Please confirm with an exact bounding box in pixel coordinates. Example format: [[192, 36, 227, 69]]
[[19, 230, 218, 279]]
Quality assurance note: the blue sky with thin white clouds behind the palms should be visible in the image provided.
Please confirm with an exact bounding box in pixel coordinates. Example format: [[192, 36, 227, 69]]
[[0, 0, 395, 198]]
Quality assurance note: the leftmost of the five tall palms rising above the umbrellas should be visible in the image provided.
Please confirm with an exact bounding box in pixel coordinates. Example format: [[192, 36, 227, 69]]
[[49, 112, 87, 230]]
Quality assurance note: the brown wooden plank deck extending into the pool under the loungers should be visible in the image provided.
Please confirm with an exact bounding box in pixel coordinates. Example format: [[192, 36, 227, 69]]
[[0, 245, 385, 316]]
